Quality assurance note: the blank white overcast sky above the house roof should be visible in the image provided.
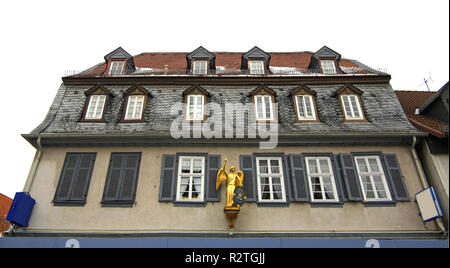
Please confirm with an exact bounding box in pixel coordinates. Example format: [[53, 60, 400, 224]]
[[0, 0, 449, 198]]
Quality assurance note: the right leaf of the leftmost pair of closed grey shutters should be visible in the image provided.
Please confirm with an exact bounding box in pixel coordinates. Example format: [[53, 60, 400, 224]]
[[70, 154, 95, 201]]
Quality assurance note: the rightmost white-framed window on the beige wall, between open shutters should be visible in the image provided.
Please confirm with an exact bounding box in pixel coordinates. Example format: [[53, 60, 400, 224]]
[[354, 155, 392, 201]]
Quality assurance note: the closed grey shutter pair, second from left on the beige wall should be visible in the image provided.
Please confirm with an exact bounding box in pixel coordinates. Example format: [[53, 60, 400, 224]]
[[102, 153, 141, 204]]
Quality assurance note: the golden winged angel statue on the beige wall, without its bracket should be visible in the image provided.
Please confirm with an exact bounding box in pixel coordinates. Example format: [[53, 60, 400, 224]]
[[216, 158, 246, 208]]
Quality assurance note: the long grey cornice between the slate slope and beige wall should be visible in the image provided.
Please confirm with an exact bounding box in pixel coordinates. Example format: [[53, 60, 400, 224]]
[[22, 132, 428, 148]]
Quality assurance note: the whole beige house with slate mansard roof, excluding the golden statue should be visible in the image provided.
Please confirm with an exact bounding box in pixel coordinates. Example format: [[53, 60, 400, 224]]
[[6, 47, 442, 245]]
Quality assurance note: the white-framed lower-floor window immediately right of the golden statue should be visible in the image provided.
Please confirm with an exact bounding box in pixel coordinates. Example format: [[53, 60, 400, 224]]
[[256, 157, 286, 203]]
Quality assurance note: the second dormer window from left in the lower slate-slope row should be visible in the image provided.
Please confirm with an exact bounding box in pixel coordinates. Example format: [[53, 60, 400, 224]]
[[120, 85, 151, 123]]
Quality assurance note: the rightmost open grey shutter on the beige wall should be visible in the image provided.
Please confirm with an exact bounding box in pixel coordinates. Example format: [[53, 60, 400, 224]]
[[384, 154, 410, 201]]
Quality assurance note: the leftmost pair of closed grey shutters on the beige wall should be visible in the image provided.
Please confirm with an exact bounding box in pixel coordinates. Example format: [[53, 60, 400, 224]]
[[53, 153, 96, 204]]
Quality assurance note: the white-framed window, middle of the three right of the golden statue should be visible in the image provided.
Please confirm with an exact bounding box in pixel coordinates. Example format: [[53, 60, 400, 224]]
[[305, 156, 339, 202]]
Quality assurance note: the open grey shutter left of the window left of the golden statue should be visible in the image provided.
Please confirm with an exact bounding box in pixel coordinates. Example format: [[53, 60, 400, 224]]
[[159, 154, 177, 202]]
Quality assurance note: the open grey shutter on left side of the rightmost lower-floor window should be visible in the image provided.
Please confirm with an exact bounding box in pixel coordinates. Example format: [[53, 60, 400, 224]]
[[339, 154, 363, 201]]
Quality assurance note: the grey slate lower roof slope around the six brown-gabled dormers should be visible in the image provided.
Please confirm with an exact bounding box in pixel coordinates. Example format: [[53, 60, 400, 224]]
[[31, 83, 418, 135]]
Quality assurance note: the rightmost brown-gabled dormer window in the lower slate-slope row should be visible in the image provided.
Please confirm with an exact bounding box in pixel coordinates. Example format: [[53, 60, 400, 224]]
[[337, 85, 367, 121]]
